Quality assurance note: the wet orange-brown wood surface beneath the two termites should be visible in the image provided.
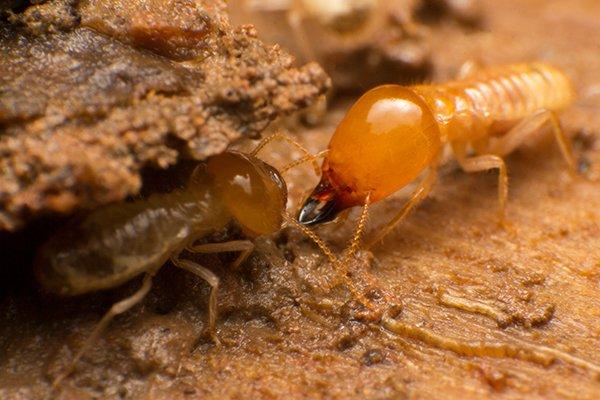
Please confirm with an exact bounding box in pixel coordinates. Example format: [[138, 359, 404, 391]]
[[0, 0, 600, 399]]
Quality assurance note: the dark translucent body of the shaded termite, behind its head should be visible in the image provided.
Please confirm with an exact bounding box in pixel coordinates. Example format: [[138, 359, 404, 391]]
[[36, 191, 226, 295]]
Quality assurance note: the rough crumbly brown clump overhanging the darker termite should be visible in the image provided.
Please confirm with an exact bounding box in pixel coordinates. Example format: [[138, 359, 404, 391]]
[[0, 0, 328, 230]]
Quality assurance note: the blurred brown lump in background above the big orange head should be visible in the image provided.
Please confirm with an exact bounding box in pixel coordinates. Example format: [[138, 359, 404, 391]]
[[229, 0, 481, 91]]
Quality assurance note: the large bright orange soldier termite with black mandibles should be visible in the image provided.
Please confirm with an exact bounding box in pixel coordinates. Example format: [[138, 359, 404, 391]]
[[298, 62, 588, 246]]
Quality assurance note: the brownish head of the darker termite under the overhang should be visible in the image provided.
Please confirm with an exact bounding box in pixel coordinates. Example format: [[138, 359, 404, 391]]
[[206, 151, 287, 236]]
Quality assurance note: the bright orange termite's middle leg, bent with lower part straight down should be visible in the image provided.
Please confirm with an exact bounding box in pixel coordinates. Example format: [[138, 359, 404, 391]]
[[452, 142, 508, 226]]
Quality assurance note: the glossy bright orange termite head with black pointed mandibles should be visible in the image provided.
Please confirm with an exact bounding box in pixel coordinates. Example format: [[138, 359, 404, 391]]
[[298, 85, 441, 225]]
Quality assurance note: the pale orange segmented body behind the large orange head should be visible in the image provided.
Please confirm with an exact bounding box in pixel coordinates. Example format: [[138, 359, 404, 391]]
[[415, 63, 575, 140]]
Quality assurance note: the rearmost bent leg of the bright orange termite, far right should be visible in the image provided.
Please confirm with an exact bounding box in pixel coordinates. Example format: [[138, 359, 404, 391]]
[[490, 110, 577, 176]]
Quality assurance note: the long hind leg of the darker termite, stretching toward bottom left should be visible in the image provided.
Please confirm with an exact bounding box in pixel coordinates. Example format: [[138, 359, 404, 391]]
[[52, 274, 152, 388]]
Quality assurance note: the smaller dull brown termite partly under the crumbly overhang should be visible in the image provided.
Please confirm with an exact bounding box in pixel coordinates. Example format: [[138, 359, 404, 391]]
[[35, 134, 333, 387]]
